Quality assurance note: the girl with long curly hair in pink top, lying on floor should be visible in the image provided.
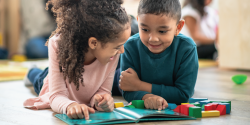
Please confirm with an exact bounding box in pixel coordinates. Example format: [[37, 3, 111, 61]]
[[24, 0, 131, 119]]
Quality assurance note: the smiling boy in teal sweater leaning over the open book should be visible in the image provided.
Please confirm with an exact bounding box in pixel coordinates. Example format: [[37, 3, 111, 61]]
[[119, 0, 198, 110]]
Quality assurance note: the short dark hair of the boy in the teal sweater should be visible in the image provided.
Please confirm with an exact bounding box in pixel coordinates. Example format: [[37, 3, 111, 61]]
[[138, 0, 181, 22]]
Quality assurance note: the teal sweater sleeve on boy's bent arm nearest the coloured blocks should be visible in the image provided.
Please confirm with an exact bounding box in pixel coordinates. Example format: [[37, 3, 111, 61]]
[[152, 46, 199, 104]]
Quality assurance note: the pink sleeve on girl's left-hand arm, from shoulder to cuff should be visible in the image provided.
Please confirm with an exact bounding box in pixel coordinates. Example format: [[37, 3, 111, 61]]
[[48, 36, 75, 114]]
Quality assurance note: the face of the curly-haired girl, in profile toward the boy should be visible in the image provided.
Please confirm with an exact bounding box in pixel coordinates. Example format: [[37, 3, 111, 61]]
[[93, 26, 131, 65]]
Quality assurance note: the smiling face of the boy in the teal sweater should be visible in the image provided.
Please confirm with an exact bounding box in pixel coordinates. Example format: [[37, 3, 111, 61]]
[[137, 14, 184, 54]]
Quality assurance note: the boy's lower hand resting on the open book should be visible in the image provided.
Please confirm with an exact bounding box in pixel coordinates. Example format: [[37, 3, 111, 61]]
[[142, 94, 168, 110]]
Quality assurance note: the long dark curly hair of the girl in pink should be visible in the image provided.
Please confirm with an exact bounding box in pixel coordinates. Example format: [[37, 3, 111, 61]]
[[46, 0, 129, 90]]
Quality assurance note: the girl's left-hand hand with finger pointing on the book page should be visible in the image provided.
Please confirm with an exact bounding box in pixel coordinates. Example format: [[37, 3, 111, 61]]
[[67, 102, 95, 120]]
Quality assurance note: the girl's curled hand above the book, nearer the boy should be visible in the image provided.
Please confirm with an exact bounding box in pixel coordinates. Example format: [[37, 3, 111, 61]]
[[93, 94, 114, 112]]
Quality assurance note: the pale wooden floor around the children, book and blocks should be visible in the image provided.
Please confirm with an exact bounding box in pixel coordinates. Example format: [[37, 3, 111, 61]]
[[0, 67, 250, 125]]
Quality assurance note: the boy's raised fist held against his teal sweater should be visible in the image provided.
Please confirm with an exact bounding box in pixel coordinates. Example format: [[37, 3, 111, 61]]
[[119, 68, 141, 91]]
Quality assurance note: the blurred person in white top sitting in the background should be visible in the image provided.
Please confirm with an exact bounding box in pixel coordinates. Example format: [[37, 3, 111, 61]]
[[181, 0, 219, 59]]
